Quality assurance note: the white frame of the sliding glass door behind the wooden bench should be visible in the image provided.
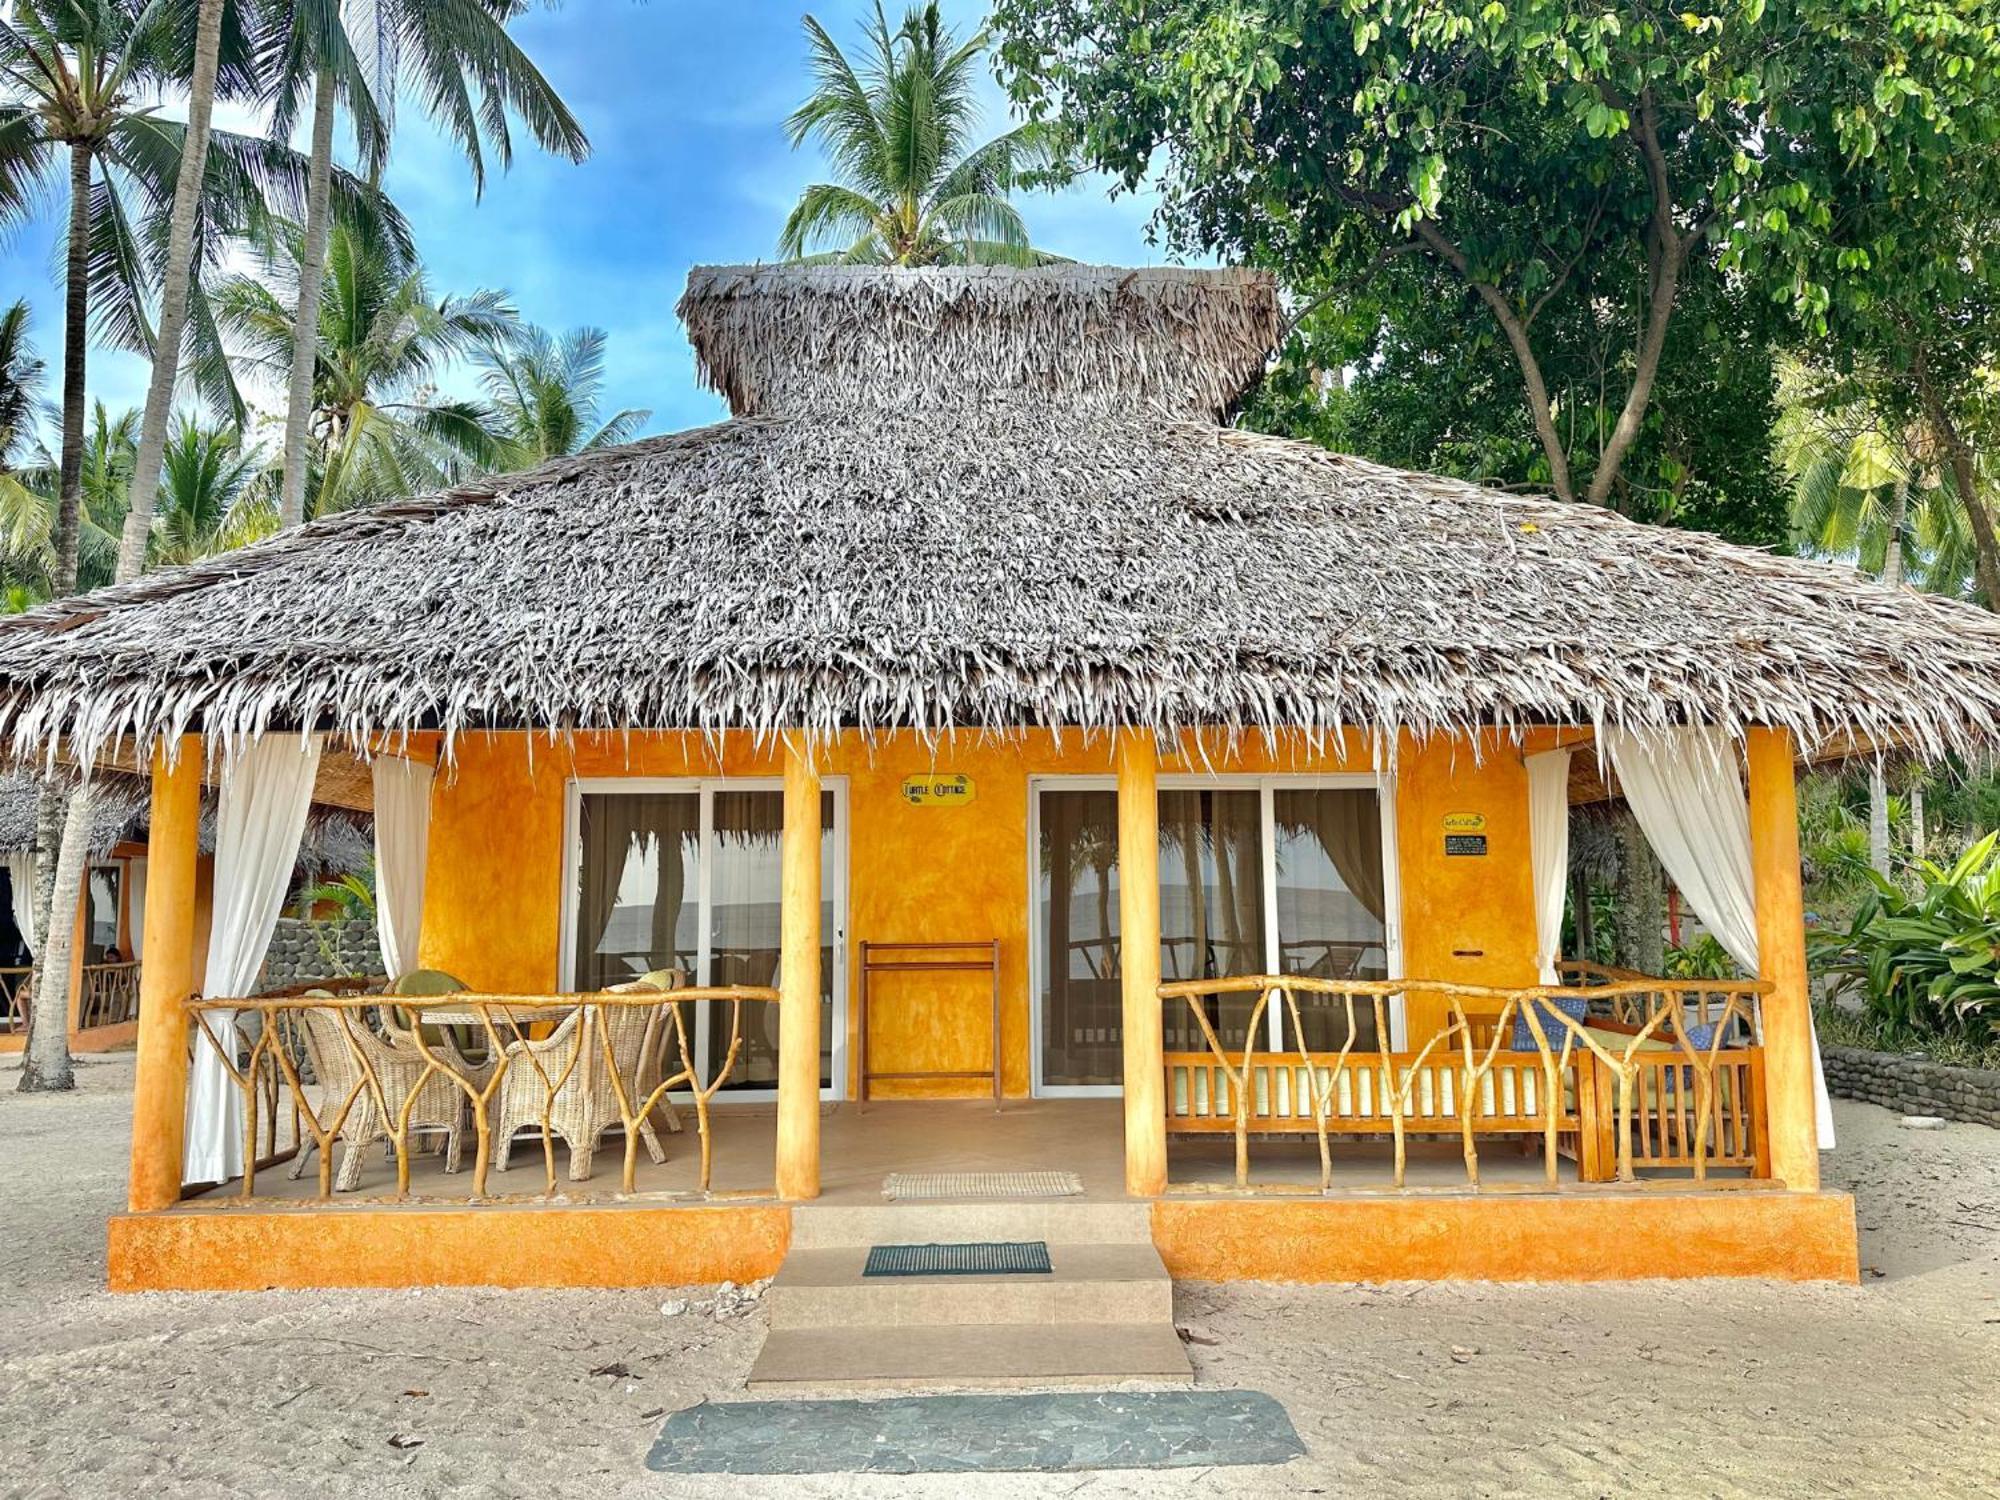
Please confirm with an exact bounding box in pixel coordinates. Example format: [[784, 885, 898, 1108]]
[[1028, 772, 1406, 1098]]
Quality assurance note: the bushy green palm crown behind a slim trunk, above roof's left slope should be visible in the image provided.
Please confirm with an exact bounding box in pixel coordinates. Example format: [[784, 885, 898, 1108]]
[[212, 220, 516, 524]]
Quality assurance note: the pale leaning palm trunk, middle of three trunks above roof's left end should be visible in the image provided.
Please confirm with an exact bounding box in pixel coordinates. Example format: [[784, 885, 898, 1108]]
[[118, 0, 222, 584]]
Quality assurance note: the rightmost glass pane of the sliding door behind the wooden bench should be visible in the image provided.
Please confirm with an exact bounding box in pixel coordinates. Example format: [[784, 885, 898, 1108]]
[[1272, 786, 1388, 1052]]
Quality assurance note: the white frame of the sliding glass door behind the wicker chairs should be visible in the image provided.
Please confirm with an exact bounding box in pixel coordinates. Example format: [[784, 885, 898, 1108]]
[[556, 776, 850, 1102]]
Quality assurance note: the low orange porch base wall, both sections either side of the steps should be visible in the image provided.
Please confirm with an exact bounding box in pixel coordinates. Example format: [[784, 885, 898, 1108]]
[[110, 1192, 1860, 1292]]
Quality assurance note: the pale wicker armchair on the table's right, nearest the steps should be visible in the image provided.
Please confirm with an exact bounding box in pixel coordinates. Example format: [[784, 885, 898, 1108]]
[[494, 984, 666, 1182]]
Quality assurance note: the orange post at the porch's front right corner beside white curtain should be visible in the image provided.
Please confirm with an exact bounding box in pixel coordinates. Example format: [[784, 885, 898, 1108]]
[[1746, 728, 1820, 1192]]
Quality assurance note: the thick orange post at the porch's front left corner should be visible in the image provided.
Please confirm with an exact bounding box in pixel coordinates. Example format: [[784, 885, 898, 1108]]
[[126, 736, 202, 1214]]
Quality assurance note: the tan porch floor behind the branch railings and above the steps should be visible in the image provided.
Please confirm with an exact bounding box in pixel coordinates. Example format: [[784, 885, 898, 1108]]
[[198, 1098, 1576, 1204]]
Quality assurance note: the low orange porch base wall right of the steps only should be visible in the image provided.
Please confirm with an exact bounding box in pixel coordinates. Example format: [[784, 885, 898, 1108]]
[[1152, 1192, 1860, 1282]]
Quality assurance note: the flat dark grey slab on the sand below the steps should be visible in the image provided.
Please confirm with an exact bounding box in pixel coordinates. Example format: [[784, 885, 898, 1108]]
[[646, 1390, 1306, 1474]]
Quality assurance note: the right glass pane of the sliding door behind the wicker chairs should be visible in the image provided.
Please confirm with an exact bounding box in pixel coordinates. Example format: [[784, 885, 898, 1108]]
[[702, 800, 838, 1090]]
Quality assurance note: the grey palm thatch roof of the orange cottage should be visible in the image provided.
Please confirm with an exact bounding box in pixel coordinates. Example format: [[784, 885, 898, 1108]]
[[0, 266, 2000, 756]]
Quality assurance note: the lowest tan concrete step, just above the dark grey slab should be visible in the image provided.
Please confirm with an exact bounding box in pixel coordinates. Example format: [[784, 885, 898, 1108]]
[[750, 1322, 1194, 1390]]
